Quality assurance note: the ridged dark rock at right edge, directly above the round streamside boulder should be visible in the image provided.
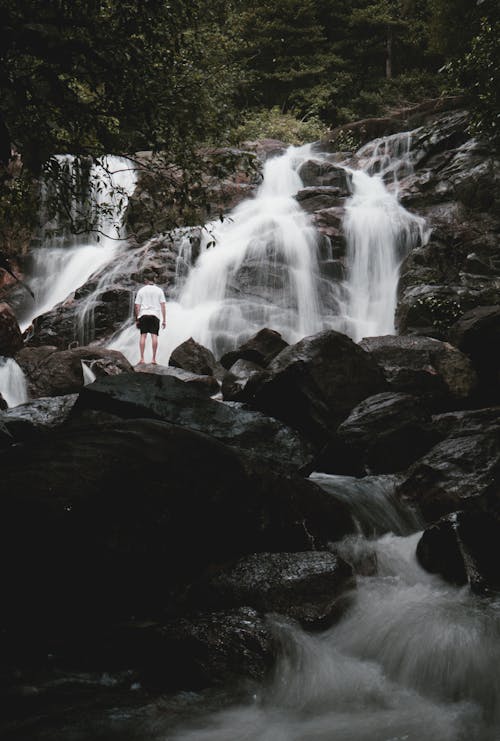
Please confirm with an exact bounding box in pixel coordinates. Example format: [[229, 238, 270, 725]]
[[397, 428, 500, 522]]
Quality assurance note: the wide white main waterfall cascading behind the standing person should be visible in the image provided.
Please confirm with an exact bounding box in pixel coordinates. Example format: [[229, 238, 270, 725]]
[[112, 134, 426, 364]]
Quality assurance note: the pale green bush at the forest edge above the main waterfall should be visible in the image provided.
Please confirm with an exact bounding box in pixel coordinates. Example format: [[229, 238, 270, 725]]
[[232, 106, 326, 145]]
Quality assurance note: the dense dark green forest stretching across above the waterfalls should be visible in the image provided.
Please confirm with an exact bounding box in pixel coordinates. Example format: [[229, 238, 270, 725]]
[[0, 0, 500, 249]]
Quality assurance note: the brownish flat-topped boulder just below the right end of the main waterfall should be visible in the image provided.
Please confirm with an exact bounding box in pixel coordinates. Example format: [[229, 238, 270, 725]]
[[360, 335, 477, 410]]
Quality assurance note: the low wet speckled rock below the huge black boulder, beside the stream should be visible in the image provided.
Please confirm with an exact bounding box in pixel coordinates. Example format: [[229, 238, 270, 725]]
[[186, 551, 354, 627]]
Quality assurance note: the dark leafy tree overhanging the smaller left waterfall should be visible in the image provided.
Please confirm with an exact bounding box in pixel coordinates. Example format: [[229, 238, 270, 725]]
[[0, 0, 240, 247]]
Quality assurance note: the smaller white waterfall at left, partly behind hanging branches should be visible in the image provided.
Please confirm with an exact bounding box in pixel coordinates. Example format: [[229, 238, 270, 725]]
[[18, 156, 136, 331]]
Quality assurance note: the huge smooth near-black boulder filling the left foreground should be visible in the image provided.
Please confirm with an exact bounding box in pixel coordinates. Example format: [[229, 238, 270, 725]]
[[0, 420, 354, 635]]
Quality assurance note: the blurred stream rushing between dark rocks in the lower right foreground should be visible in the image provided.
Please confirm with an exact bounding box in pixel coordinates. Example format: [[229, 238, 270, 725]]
[[165, 474, 500, 741]]
